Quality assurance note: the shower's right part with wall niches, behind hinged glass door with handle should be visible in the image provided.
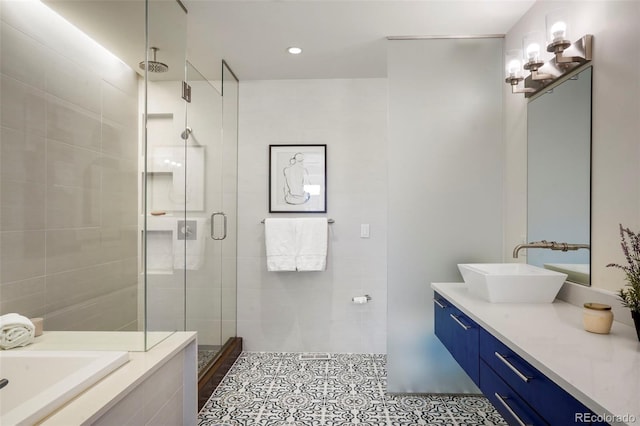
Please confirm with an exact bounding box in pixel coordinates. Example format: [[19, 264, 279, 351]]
[[140, 53, 238, 373]]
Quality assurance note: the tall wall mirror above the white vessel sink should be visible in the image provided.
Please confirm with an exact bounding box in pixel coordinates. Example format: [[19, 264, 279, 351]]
[[527, 67, 592, 285]]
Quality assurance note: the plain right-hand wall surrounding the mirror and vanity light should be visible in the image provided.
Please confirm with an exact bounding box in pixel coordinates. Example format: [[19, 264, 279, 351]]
[[503, 1, 640, 291]]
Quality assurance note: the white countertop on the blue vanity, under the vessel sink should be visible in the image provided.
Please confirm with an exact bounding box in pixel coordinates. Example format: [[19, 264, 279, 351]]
[[431, 283, 640, 425]]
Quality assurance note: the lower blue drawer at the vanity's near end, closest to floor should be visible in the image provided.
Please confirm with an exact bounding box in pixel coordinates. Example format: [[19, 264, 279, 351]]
[[480, 361, 548, 426]]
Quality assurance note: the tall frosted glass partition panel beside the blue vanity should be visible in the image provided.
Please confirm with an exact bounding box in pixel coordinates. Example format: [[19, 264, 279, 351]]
[[387, 39, 503, 393]]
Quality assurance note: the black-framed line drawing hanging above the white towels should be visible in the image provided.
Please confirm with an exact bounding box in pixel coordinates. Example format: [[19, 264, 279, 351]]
[[269, 145, 327, 213]]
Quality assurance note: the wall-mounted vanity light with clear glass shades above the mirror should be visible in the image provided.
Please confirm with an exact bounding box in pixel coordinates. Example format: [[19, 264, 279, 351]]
[[505, 9, 593, 98]]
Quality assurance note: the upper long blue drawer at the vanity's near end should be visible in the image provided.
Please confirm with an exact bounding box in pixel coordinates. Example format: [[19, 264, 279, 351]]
[[480, 329, 591, 426]]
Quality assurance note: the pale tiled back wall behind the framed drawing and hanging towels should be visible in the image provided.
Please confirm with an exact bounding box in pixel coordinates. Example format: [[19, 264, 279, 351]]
[[238, 79, 387, 353]]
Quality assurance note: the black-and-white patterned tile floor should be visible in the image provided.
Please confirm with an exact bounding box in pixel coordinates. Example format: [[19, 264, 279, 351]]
[[198, 352, 506, 426]]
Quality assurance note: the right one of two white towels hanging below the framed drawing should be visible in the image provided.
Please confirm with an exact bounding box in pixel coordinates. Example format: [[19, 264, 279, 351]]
[[296, 218, 329, 271]]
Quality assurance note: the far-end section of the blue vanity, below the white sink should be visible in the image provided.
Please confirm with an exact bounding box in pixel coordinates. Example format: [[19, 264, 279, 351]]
[[433, 293, 480, 385]]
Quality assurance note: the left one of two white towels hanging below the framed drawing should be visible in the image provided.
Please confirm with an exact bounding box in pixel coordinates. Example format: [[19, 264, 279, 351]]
[[264, 218, 296, 271]]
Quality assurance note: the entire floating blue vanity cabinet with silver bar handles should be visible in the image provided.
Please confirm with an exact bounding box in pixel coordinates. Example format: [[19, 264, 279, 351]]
[[434, 292, 606, 426]]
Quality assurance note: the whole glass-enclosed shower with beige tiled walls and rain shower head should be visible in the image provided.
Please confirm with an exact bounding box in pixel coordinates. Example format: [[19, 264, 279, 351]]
[[0, 0, 238, 392]]
